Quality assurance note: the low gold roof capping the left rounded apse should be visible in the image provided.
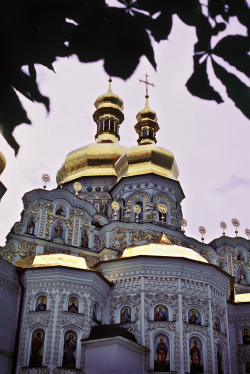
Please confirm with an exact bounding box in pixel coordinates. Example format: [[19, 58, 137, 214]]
[[15, 253, 90, 270]]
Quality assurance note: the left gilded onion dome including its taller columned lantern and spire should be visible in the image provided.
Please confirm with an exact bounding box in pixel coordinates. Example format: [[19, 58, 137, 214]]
[[57, 78, 127, 185]]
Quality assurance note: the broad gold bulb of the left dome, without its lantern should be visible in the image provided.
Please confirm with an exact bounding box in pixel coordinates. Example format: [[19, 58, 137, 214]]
[[56, 143, 127, 184]]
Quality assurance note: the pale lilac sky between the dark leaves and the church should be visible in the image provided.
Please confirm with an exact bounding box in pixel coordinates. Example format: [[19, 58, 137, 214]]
[[0, 16, 250, 245]]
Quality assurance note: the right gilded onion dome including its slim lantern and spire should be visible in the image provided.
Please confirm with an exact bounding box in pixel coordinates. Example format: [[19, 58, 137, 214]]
[[115, 95, 179, 180]]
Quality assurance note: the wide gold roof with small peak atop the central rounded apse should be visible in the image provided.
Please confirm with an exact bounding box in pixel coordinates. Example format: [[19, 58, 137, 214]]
[[121, 233, 208, 263]]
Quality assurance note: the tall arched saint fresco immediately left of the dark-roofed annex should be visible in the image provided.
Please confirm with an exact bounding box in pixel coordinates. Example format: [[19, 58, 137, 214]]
[[62, 331, 77, 369]]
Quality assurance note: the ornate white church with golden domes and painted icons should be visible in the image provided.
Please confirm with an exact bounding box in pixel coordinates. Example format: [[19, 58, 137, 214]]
[[0, 79, 250, 374]]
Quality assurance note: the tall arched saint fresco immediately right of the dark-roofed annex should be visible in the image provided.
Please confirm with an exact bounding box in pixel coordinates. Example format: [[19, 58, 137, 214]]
[[154, 334, 170, 372]]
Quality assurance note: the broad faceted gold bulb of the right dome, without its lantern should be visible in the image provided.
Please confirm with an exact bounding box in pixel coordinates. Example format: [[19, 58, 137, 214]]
[[115, 144, 179, 180]]
